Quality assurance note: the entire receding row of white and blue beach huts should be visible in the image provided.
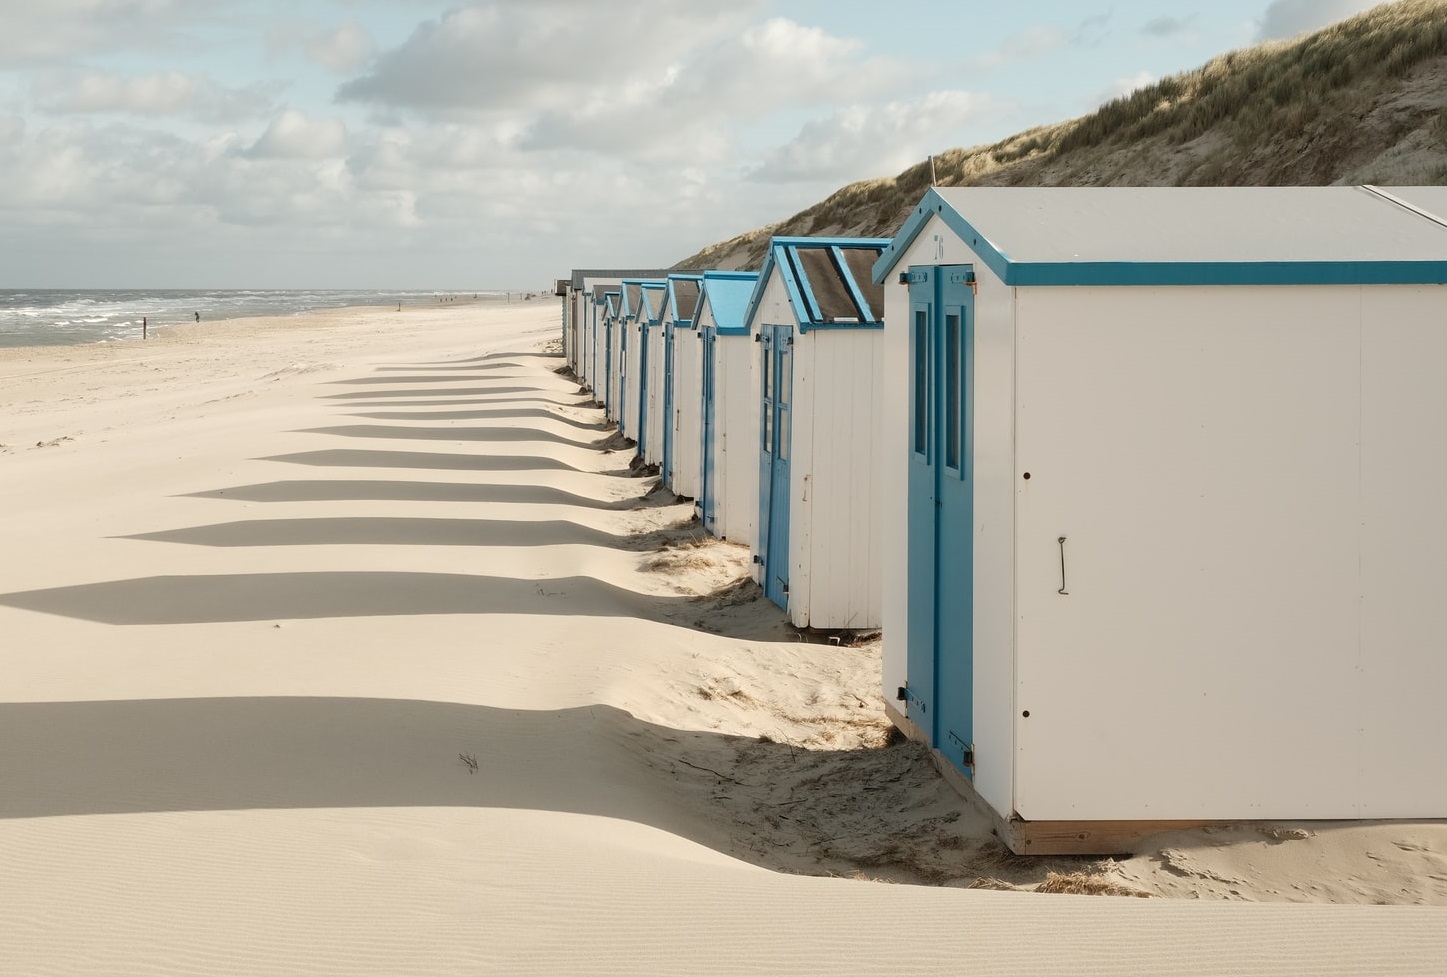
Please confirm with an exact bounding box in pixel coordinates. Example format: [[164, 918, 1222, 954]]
[[559, 187, 1447, 853]]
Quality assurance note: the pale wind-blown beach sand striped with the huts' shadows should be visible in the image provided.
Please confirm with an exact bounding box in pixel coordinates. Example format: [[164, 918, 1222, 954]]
[[0, 300, 1447, 977]]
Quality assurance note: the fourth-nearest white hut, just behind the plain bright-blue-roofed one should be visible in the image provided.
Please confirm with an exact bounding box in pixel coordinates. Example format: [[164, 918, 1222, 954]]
[[660, 275, 703, 499]]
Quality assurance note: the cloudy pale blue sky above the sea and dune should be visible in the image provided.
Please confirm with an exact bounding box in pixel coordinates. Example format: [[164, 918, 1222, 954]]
[[0, 0, 1394, 289]]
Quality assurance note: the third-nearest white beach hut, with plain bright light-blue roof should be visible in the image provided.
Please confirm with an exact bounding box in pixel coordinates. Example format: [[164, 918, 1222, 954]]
[[695, 271, 758, 546]]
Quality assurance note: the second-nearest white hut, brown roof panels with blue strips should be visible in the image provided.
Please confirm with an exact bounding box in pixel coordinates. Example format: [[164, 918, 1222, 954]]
[[745, 237, 890, 628]]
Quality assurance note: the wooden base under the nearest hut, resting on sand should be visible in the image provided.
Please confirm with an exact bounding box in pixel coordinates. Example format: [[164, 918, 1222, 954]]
[[884, 702, 1221, 855]]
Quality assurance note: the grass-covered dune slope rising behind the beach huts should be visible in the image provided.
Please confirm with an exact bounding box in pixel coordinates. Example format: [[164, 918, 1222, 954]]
[[679, 0, 1447, 268]]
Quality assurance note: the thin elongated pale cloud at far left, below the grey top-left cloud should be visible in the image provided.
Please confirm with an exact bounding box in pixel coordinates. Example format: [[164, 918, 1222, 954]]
[[32, 71, 272, 122]]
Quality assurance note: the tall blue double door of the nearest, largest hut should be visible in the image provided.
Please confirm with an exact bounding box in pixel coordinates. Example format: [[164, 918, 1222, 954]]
[[906, 265, 974, 774]]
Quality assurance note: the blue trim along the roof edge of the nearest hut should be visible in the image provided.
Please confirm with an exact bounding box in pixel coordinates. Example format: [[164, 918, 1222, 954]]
[[873, 190, 1447, 287]]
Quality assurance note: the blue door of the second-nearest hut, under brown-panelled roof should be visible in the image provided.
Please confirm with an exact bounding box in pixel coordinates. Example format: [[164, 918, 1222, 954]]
[[758, 326, 794, 611]]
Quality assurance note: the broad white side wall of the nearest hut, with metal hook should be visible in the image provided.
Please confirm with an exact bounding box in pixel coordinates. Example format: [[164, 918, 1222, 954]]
[[1016, 287, 1447, 818]]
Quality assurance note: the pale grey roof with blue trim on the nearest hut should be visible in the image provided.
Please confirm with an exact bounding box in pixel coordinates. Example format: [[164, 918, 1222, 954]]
[[871, 187, 1447, 285]]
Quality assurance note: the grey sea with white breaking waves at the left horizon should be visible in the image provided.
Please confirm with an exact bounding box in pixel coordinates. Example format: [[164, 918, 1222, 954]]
[[0, 288, 518, 347]]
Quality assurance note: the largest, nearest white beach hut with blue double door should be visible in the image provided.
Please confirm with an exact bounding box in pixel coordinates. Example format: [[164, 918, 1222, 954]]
[[874, 187, 1447, 853]]
